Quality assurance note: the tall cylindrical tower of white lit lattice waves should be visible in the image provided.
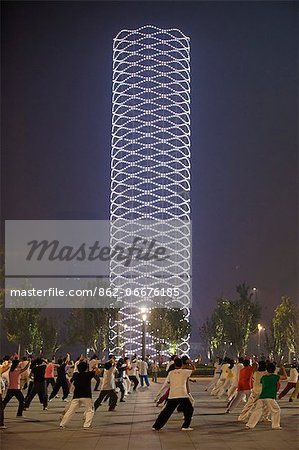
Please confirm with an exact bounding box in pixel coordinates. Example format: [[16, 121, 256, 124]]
[[110, 26, 191, 354]]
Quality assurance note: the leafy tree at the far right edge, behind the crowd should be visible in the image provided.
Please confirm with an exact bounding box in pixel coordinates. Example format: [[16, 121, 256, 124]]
[[272, 296, 299, 360]]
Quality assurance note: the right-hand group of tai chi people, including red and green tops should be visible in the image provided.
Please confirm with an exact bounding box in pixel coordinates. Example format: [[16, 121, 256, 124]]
[[206, 358, 299, 430]]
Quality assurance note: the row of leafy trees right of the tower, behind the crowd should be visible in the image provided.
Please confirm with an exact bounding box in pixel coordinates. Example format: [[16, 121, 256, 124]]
[[199, 283, 299, 360]]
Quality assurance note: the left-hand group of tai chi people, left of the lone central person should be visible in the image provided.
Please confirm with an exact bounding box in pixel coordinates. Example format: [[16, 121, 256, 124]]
[[0, 353, 154, 429]]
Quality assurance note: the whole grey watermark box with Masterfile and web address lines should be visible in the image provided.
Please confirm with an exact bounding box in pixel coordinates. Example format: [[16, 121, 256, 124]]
[[5, 219, 192, 308]]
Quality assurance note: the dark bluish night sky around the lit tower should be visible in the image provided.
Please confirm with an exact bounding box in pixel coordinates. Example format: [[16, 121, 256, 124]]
[[2, 2, 299, 339]]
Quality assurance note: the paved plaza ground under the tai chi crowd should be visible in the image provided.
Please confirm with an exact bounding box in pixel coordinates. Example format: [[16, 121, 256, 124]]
[[0, 379, 299, 450]]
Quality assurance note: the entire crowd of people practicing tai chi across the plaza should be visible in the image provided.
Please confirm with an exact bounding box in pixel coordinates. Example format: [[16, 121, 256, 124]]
[[0, 354, 299, 431]]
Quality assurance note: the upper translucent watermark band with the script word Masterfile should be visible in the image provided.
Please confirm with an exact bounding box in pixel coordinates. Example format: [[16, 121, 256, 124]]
[[5, 219, 191, 277]]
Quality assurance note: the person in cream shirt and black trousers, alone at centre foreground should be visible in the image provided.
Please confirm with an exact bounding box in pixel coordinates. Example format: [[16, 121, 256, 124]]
[[152, 358, 194, 431]]
